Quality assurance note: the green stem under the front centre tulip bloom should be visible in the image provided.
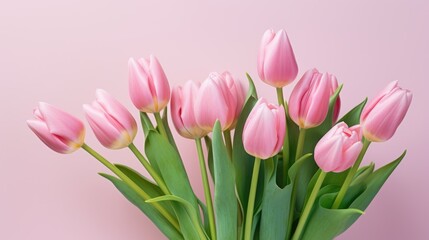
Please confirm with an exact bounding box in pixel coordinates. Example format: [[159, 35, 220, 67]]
[[244, 157, 261, 240]]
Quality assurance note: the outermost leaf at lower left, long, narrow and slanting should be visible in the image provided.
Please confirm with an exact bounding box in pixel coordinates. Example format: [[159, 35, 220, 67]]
[[99, 173, 183, 239]]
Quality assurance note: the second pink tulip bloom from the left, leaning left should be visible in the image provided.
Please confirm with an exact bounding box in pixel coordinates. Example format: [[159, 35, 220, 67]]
[[83, 89, 137, 149]]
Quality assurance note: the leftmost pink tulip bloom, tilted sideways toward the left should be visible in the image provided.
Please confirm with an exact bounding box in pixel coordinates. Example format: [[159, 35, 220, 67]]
[[27, 102, 85, 153]]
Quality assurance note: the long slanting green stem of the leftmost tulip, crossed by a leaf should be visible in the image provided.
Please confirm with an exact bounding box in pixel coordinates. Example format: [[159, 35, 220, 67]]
[[82, 143, 180, 232]]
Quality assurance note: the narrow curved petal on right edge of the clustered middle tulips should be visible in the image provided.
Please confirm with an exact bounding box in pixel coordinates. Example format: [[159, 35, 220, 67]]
[[222, 72, 246, 130]]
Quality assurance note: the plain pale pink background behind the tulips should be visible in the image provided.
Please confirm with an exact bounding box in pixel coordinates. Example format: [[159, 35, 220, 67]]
[[0, 0, 429, 240]]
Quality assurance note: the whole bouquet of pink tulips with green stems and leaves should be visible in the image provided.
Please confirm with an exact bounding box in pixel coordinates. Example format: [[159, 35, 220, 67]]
[[27, 30, 412, 240]]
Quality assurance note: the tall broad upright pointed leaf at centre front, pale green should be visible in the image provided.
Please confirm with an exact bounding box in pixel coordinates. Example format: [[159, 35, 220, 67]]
[[212, 121, 238, 240]]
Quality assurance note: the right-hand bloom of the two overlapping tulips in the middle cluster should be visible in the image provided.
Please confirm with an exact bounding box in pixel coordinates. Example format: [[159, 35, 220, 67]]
[[194, 72, 237, 132]]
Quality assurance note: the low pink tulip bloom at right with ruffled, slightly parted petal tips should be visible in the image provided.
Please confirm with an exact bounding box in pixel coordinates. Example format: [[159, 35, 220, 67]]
[[314, 122, 363, 172]]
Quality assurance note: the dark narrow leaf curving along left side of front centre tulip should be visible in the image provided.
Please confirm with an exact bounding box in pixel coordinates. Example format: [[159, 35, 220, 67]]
[[232, 96, 256, 216]]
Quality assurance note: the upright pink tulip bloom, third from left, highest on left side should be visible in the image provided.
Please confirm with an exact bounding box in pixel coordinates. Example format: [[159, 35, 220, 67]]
[[128, 55, 170, 113]]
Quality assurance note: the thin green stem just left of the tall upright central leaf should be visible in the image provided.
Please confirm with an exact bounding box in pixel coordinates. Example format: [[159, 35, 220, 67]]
[[195, 138, 216, 240]]
